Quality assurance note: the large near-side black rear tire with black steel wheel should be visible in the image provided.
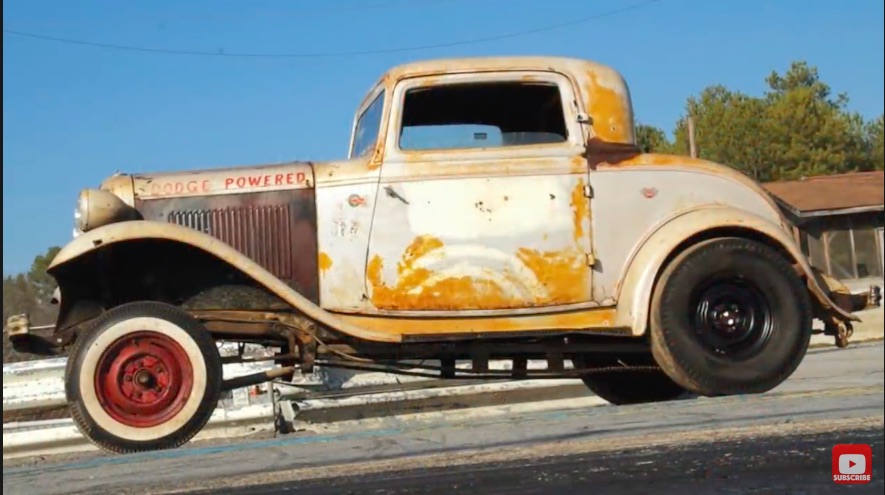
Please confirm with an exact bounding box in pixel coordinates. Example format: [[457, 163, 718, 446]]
[[650, 238, 812, 396]]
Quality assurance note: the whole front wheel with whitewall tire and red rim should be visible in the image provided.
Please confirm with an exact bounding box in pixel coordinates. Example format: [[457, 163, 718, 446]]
[[65, 302, 222, 453]]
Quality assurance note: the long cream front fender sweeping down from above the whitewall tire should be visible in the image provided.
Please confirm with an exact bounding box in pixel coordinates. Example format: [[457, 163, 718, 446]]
[[48, 220, 401, 343]]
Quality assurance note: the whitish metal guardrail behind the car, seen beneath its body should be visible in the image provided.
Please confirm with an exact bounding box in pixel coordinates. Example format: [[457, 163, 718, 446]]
[[3, 344, 579, 458]]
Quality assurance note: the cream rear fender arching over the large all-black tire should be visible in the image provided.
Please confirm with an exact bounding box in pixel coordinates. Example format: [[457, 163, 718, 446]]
[[617, 206, 860, 335]]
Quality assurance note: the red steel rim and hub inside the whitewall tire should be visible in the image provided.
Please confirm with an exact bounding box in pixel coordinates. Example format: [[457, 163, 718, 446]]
[[95, 332, 194, 428]]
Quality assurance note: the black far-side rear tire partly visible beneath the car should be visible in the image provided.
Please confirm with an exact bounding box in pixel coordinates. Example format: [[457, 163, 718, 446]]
[[572, 355, 689, 406]]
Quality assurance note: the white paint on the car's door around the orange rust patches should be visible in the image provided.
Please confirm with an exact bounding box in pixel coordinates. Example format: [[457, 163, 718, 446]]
[[367, 168, 592, 310]]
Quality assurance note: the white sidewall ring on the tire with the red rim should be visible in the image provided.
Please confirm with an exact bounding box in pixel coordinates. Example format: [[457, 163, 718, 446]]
[[74, 316, 207, 441]]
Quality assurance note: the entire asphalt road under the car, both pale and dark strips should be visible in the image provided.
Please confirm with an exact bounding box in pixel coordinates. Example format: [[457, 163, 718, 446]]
[[3, 343, 885, 495]]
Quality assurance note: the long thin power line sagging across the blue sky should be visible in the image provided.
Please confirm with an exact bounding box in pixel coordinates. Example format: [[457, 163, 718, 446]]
[[3, 0, 660, 58]]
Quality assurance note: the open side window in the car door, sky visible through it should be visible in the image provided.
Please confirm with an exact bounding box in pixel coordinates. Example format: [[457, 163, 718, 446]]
[[399, 82, 568, 150]]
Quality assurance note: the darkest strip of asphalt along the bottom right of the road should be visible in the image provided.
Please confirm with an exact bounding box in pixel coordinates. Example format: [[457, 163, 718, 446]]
[[192, 427, 885, 495]]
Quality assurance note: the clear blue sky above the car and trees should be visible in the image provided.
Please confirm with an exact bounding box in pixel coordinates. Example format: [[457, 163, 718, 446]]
[[3, 0, 885, 274]]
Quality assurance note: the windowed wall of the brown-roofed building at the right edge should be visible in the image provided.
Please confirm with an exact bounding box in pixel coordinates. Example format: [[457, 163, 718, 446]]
[[805, 216, 883, 280]]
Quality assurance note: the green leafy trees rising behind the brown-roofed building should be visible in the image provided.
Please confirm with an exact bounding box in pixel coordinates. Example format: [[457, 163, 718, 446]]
[[674, 61, 882, 181]]
